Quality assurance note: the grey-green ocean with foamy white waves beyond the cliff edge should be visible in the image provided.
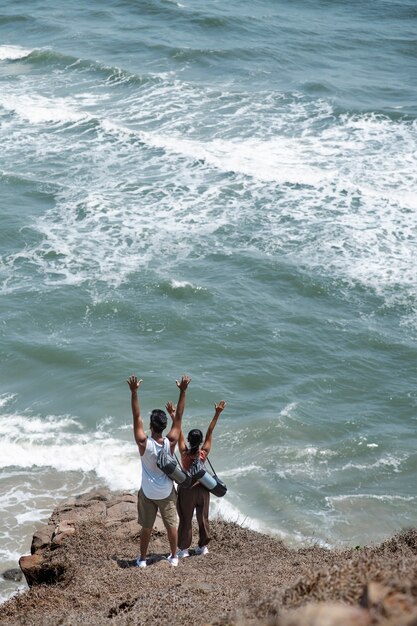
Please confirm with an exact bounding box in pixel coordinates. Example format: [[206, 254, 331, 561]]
[[0, 0, 417, 600]]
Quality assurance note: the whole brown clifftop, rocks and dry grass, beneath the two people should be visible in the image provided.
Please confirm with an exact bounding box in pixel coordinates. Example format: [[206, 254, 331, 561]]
[[0, 490, 417, 626]]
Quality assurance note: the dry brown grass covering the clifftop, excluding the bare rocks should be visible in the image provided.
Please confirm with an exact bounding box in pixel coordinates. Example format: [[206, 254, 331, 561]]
[[0, 521, 417, 626]]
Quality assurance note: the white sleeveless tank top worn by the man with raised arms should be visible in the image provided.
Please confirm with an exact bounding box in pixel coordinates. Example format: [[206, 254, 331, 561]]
[[140, 437, 174, 500]]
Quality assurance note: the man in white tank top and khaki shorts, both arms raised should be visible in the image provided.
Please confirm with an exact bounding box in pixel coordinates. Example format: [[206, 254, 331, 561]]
[[127, 376, 191, 567]]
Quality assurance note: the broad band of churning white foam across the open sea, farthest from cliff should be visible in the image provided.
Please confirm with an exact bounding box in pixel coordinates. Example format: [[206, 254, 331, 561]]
[[0, 78, 417, 316]]
